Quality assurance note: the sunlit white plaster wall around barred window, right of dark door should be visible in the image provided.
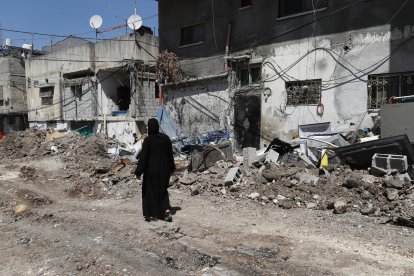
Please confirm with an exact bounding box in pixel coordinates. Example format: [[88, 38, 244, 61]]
[[256, 26, 414, 142]]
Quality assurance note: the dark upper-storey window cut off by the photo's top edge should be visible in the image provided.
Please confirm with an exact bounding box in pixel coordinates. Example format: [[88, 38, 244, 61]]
[[279, 0, 327, 17]]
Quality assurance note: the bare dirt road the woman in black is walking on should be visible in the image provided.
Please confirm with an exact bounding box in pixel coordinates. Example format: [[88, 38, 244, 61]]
[[0, 157, 414, 275]]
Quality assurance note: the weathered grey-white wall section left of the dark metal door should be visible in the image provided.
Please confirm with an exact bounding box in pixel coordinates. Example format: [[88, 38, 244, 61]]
[[165, 78, 233, 134]]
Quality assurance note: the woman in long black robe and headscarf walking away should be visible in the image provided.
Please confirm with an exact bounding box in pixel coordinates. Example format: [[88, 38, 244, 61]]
[[135, 118, 175, 221]]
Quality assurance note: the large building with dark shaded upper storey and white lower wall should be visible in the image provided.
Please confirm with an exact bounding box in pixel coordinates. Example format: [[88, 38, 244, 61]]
[[158, 0, 414, 151]]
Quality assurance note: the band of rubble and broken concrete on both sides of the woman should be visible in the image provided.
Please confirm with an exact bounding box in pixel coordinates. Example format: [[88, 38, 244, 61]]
[[0, 129, 414, 229]]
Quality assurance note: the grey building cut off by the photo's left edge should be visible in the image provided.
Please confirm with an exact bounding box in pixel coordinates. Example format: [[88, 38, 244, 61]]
[[0, 39, 39, 139]]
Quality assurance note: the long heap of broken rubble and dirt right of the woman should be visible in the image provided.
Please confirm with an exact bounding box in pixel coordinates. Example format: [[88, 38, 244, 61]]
[[172, 163, 414, 224]]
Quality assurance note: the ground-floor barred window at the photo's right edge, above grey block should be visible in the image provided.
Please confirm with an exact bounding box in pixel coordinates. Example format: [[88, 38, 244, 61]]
[[368, 72, 414, 109]]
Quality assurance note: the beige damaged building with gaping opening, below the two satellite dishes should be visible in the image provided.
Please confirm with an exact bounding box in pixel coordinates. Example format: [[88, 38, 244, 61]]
[[26, 32, 159, 142]]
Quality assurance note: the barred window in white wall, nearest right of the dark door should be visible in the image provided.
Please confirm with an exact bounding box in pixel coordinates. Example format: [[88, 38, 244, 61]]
[[286, 79, 322, 106]]
